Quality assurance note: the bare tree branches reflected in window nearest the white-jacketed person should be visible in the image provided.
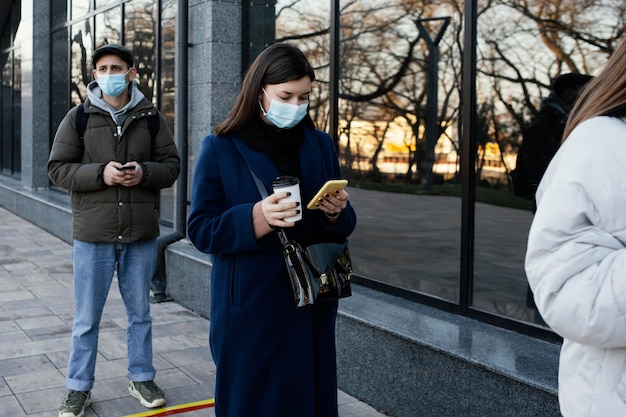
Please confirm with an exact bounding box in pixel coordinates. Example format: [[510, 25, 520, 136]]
[[478, 0, 626, 185]]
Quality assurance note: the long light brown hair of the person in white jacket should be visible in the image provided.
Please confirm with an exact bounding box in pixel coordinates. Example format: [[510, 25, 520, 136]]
[[563, 38, 626, 142]]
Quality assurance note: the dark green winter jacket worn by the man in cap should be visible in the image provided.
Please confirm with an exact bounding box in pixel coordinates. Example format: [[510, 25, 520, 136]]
[[48, 98, 180, 243]]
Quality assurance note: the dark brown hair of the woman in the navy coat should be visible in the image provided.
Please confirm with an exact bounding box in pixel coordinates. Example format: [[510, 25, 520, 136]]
[[214, 43, 315, 135]]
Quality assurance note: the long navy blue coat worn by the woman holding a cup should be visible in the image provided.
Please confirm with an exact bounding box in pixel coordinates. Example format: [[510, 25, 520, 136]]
[[188, 129, 356, 417]]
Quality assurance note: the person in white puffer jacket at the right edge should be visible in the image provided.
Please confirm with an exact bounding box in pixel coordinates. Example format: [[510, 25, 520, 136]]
[[526, 37, 626, 417]]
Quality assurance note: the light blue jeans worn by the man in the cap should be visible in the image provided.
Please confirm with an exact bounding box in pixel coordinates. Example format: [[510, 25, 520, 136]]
[[66, 239, 157, 391]]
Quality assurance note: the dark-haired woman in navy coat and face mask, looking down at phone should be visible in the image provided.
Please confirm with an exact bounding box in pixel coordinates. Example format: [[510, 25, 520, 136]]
[[188, 44, 356, 417]]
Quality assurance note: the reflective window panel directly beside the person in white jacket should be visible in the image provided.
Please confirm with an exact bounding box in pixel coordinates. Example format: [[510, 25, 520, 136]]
[[473, 0, 625, 326]]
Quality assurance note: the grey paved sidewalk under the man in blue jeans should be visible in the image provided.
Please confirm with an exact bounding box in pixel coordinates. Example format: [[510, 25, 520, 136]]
[[0, 207, 383, 417]]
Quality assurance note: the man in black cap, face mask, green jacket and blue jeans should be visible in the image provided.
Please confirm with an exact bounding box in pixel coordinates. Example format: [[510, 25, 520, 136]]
[[48, 45, 180, 417]]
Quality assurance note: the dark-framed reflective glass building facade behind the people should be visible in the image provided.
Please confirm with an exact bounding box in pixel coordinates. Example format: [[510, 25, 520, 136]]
[[0, 0, 626, 339]]
